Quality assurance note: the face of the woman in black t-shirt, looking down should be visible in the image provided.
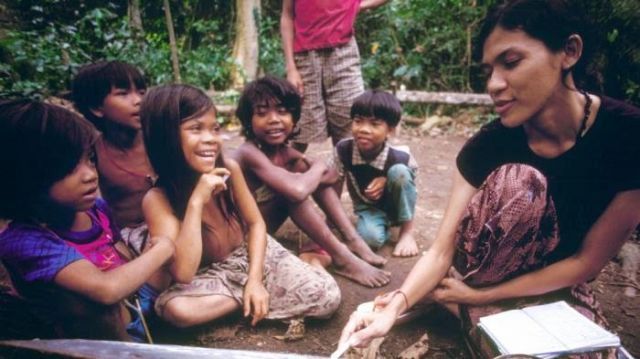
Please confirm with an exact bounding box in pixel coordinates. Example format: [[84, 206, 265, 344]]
[[482, 26, 567, 127]]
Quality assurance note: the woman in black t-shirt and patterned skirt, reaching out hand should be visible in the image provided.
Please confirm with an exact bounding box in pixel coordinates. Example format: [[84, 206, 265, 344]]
[[341, 0, 640, 356]]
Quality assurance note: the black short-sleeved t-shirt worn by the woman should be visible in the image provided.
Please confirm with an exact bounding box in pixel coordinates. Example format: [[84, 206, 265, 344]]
[[456, 97, 640, 260]]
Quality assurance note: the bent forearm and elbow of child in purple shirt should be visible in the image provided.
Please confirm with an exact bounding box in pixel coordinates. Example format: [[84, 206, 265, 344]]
[[54, 237, 175, 305]]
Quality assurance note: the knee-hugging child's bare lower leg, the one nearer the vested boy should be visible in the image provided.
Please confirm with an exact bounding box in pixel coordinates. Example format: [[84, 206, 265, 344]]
[[314, 187, 387, 266]]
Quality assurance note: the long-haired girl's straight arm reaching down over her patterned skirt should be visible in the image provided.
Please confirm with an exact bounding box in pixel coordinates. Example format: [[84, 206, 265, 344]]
[[225, 159, 269, 325]]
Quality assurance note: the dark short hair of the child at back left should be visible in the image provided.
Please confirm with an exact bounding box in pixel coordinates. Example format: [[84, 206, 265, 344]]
[[71, 61, 147, 131]]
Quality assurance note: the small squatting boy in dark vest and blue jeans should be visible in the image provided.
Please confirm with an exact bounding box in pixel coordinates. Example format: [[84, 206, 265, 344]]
[[334, 90, 418, 257]]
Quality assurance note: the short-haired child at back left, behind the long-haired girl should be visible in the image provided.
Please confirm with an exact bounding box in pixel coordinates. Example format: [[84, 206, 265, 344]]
[[72, 61, 155, 254]]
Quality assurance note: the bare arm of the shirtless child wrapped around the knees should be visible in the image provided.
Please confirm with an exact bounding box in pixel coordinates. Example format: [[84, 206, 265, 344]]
[[233, 142, 327, 202]]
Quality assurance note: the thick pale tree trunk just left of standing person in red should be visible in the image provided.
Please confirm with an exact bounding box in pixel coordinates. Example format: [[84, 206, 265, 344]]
[[231, 0, 260, 88]]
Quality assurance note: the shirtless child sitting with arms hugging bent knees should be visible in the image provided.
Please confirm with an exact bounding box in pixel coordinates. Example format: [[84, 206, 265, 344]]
[[233, 76, 390, 287]]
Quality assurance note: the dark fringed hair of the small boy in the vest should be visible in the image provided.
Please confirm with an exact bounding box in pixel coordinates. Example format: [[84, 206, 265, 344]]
[[351, 90, 402, 127]]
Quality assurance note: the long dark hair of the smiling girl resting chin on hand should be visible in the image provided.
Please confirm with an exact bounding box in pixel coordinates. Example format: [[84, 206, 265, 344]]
[[140, 85, 237, 219]]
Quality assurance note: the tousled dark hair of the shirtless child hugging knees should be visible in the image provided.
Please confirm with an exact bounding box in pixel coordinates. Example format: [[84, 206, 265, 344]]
[[236, 75, 302, 140]]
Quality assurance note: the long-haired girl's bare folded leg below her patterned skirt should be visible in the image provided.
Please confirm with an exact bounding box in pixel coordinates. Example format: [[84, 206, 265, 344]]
[[162, 295, 240, 328]]
